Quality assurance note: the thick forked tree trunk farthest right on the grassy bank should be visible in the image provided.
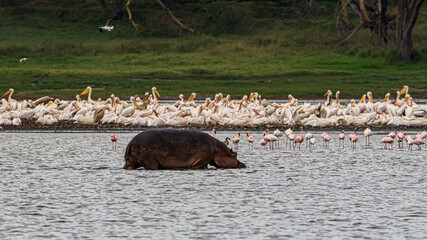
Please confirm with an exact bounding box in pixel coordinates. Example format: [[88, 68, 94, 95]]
[[396, 0, 424, 61]]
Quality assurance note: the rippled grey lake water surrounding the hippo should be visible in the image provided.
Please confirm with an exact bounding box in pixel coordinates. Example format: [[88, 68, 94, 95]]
[[0, 132, 427, 239]]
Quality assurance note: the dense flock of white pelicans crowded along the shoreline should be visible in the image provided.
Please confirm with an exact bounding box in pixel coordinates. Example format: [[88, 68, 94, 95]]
[[0, 86, 427, 128]]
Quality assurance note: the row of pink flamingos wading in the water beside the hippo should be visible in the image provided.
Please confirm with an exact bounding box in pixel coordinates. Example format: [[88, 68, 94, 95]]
[[212, 127, 427, 151]]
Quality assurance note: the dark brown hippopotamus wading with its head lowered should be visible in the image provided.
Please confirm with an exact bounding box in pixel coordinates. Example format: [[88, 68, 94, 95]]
[[123, 129, 246, 170]]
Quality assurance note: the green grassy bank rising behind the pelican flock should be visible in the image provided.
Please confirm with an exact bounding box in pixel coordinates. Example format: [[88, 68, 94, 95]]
[[0, 0, 427, 98]]
